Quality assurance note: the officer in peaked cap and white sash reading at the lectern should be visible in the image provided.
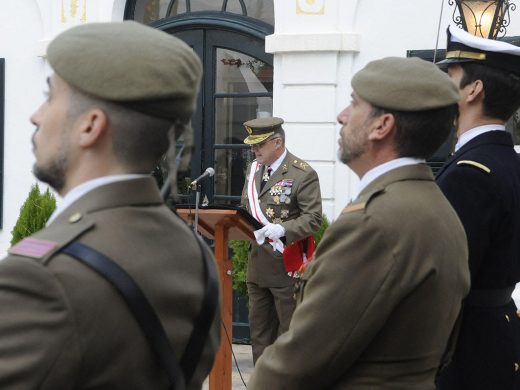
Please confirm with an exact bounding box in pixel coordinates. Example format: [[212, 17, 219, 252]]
[[242, 118, 322, 362]]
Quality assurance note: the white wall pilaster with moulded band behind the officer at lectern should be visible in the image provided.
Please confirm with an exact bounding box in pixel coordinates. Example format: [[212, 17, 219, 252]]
[[266, 0, 360, 219]]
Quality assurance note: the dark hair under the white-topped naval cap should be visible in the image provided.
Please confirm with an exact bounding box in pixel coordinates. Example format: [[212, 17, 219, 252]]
[[459, 63, 520, 122]]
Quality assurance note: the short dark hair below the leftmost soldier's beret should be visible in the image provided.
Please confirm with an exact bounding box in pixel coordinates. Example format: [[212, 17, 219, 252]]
[[68, 88, 172, 174]]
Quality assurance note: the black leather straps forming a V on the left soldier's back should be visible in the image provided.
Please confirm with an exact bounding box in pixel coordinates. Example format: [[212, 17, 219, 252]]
[[61, 233, 218, 390]]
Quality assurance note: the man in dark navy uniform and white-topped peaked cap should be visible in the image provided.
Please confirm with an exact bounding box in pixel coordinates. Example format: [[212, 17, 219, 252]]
[[437, 26, 520, 390]]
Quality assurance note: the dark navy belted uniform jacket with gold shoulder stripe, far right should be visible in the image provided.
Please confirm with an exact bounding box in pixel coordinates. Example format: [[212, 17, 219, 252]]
[[437, 130, 520, 390]]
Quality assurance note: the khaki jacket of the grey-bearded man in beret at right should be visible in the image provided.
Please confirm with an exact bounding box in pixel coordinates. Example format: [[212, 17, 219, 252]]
[[248, 165, 469, 390]]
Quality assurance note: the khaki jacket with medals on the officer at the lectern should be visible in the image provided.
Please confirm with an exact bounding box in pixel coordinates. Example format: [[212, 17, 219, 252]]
[[242, 152, 322, 287]]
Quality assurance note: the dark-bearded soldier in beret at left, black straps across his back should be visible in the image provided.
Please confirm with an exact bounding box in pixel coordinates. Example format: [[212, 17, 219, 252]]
[[0, 22, 219, 390]]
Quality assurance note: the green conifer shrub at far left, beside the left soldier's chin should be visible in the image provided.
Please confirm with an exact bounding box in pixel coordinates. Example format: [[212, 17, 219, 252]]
[[11, 184, 56, 245]]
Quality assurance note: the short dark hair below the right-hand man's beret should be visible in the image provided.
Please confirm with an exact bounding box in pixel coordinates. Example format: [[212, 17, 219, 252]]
[[372, 104, 458, 159]]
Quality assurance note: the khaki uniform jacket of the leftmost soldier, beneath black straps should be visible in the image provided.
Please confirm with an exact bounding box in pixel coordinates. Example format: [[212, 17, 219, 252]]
[[0, 178, 219, 390]]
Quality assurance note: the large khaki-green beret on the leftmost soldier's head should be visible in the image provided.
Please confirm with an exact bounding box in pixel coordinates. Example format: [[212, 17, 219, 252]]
[[47, 21, 202, 122]]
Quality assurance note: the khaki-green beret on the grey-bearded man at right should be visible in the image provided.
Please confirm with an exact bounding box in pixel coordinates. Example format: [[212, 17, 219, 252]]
[[352, 57, 459, 111]]
